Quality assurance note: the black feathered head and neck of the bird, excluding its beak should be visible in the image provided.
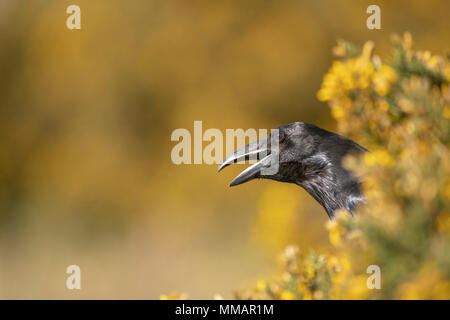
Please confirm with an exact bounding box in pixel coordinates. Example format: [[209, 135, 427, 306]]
[[262, 122, 367, 218]]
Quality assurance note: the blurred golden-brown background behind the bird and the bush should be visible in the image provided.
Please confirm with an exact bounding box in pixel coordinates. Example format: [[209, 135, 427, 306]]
[[0, 0, 450, 299]]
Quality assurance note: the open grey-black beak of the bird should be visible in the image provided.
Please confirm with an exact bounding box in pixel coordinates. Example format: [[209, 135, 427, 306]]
[[217, 137, 273, 187]]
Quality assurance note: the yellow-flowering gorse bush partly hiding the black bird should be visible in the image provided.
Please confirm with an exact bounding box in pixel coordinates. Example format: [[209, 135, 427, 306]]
[[160, 34, 450, 299]]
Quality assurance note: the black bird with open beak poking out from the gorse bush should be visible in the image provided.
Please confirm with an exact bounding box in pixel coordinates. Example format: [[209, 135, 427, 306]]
[[218, 122, 367, 219]]
